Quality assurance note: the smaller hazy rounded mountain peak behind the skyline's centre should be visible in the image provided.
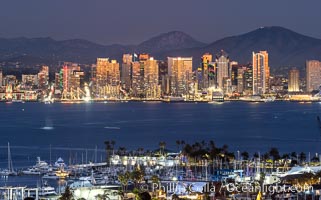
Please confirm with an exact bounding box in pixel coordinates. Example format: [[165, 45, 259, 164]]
[[138, 31, 205, 53]]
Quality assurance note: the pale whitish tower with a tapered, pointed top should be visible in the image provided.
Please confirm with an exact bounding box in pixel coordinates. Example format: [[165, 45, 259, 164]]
[[215, 50, 231, 93]]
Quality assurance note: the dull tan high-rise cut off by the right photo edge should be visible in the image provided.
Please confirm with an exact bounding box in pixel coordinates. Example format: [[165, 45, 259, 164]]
[[306, 60, 321, 92]]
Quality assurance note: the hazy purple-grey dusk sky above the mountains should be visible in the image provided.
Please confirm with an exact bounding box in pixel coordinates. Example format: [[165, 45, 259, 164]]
[[0, 0, 321, 44]]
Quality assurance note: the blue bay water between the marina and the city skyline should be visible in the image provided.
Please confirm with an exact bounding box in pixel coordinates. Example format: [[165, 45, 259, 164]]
[[0, 102, 321, 168]]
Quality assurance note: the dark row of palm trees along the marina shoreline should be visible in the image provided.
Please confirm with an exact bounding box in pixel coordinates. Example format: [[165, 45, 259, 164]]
[[105, 140, 320, 170]]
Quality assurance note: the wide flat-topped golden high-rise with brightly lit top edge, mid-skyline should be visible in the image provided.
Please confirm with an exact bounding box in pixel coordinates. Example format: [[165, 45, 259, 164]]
[[168, 57, 193, 96]]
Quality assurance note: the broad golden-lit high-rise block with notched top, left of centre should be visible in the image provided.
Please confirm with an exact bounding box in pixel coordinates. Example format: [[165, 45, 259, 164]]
[[96, 58, 120, 98]]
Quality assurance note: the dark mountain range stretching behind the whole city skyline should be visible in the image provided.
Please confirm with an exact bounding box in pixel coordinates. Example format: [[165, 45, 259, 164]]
[[0, 26, 321, 68]]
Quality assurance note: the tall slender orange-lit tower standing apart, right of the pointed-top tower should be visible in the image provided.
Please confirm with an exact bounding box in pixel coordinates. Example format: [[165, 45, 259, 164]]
[[252, 51, 270, 95]]
